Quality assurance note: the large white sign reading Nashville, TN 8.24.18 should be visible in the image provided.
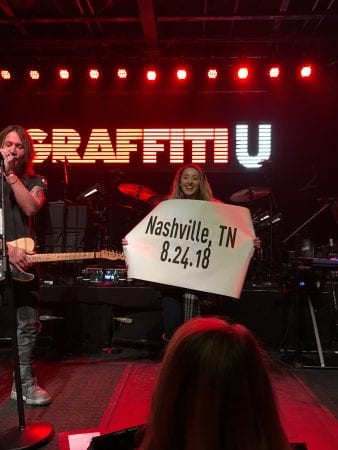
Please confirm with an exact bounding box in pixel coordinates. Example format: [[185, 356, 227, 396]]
[[124, 199, 255, 298]]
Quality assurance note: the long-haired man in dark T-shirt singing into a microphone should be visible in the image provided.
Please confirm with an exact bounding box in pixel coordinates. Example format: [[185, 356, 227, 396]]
[[0, 125, 51, 406]]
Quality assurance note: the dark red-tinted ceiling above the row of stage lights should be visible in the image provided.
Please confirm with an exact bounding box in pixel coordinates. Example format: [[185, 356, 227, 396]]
[[0, 0, 338, 64]]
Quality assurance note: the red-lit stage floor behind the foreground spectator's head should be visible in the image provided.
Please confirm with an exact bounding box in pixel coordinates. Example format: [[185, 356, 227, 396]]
[[0, 348, 338, 450]]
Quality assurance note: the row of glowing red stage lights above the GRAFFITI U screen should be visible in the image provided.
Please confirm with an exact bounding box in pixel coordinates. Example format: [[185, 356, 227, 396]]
[[0, 64, 313, 82]]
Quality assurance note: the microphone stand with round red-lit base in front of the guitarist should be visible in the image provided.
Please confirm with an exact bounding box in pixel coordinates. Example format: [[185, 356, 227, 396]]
[[0, 157, 54, 450]]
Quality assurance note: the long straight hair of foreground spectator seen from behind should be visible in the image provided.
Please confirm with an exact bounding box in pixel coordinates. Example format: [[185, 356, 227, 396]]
[[139, 318, 290, 450]]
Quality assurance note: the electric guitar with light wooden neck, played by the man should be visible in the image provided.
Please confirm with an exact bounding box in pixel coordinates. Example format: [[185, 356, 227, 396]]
[[8, 238, 125, 282]]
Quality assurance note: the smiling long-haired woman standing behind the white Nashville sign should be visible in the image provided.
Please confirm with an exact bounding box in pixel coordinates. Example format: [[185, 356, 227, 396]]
[[162, 164, 261, 341]]
